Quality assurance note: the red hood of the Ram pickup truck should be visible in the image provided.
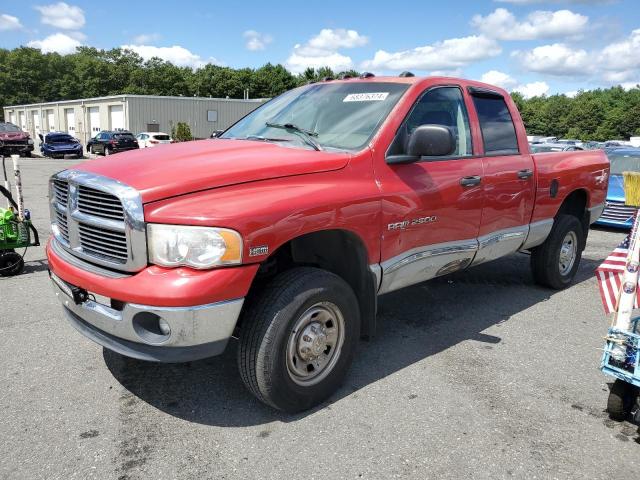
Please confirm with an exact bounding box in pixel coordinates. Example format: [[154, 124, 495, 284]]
[[74, 139, 350, 203]]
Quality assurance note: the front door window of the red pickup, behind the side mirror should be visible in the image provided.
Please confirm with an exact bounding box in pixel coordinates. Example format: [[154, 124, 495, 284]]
[[388, 87, 473, 158]]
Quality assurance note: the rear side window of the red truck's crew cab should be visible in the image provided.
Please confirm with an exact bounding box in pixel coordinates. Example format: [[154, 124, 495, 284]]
[[470, 89, 519, 155]]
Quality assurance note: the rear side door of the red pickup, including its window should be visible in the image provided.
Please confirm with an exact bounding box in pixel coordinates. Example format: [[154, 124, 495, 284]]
[[469, 87, 535, 265]]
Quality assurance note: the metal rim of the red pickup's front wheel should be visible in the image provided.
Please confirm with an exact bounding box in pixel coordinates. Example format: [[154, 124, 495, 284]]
[[287, 302, 344, 386]]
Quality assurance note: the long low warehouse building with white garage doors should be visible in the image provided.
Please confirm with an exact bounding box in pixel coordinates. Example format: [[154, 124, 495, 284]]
[[4, 95, 265, 145]]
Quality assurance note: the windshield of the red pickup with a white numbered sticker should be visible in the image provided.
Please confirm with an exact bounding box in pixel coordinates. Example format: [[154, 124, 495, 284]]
[[219, 80, 408, 150]]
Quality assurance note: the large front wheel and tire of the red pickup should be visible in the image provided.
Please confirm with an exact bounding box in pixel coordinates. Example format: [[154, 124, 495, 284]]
[[238, 267, 360, 413]]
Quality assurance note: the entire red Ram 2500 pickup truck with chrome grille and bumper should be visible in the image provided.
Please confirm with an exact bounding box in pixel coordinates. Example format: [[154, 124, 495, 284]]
[[47, 74, 609, 411]]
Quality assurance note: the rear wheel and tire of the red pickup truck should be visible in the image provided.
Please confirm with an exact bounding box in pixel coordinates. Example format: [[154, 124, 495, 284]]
[[531, 214, 584, 290]]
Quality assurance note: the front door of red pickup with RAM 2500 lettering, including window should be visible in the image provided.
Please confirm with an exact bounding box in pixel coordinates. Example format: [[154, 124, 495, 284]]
[[376, 86, 483, 293]]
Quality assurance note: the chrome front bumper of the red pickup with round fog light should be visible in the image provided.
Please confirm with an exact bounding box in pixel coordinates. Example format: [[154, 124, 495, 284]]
[[52, 276, 244, 363]]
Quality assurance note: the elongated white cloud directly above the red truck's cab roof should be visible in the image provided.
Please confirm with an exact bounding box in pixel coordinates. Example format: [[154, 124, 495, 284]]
[[362, 35, 502, 70]]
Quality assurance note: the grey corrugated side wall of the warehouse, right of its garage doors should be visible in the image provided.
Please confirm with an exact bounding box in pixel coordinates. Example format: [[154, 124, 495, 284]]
[[127, 97, 262, 138]]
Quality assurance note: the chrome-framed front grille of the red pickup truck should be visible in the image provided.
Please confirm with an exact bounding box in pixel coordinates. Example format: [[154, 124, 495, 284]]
[[49, 170, 147, 272]]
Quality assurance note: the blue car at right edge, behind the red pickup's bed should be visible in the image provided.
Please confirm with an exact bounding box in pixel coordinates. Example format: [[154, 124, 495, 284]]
[[596, 148, 640, 228]]
